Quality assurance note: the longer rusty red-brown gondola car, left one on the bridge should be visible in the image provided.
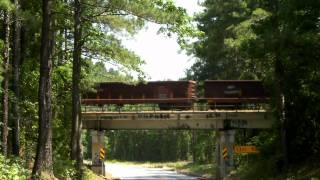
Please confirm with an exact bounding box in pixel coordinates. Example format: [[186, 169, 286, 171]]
[[83, 81, 196, 110]]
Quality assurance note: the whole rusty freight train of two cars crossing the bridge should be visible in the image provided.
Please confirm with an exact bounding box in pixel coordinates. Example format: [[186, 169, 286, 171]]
[[82, 80, 268, 110]]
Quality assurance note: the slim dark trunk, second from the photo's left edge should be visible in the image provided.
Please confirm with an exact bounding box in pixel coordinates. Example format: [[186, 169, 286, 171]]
[[12, 0, 21, 156]]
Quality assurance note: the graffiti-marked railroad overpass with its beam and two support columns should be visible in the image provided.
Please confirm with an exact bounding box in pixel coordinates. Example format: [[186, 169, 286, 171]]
[[81, 107, 273, 179]]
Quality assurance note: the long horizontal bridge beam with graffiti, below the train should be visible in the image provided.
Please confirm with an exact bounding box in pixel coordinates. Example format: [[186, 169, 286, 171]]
[[82, 111, 273, 130]]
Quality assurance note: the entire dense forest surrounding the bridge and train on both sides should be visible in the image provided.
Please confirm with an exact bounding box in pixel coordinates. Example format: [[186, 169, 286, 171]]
[[0, 0, 320, 179]]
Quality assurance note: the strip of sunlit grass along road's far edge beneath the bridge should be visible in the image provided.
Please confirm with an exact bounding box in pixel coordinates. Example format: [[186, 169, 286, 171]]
[[107, 160, 216, 178]]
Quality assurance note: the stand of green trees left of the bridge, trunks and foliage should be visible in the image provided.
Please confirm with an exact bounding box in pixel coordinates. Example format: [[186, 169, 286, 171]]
[[0, 0, 192, 179]]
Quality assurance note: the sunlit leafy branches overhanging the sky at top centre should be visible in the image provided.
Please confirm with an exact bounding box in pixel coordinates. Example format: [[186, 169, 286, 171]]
[[104, 0, 198, 45]]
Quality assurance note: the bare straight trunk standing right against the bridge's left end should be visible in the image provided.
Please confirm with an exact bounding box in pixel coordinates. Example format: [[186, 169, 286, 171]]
[[71, 0, 83, 174]]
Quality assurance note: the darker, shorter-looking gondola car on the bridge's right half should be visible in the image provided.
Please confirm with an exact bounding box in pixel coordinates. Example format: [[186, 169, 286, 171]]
[[204, 80, 268, 108]]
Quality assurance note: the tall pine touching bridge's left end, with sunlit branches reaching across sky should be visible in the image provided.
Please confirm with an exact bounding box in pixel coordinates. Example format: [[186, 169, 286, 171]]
[[71, 0, 192, 174]]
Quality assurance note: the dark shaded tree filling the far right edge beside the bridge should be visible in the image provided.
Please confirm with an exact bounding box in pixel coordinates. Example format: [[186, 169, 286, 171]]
[[244, 1, 320, 169]]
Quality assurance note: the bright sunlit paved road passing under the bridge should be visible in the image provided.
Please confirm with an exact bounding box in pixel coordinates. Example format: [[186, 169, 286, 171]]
[[106, 163, 198, 180]]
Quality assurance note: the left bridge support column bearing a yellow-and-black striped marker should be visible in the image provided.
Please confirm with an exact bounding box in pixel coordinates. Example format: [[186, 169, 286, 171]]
[[91, 130, 105, 176]]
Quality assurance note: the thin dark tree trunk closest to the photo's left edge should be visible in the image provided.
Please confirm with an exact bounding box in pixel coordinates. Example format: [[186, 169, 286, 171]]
[[2, 11, 10, 156]]
